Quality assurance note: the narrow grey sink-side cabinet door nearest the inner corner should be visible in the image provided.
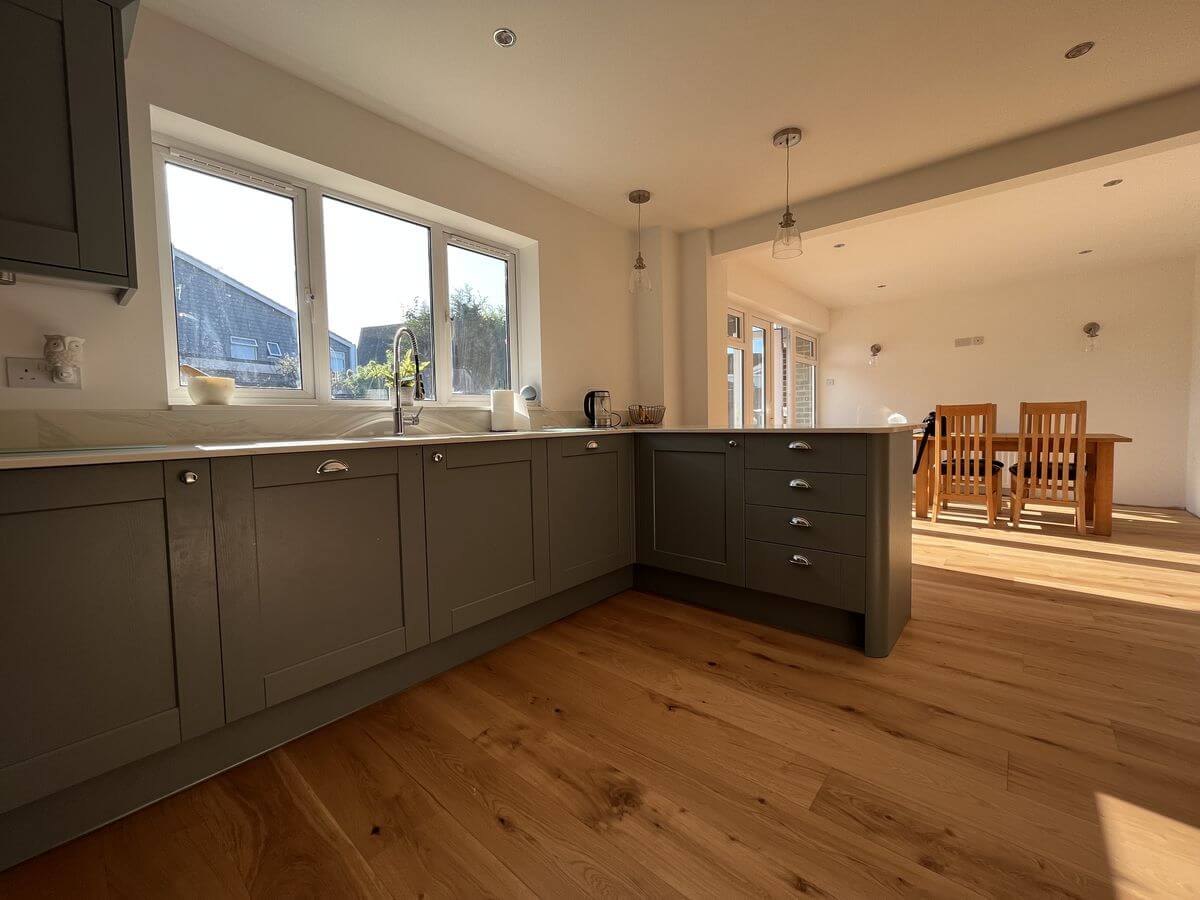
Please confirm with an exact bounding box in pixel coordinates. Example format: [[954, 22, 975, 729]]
[[546, 434, 634, 593]]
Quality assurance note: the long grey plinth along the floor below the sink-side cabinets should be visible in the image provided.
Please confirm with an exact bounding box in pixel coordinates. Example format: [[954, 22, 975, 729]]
[[0, 566, 634, 871]]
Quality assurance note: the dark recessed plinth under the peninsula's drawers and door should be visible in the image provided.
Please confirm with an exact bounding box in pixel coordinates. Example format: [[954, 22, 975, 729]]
[[634, 565, 865, 649]]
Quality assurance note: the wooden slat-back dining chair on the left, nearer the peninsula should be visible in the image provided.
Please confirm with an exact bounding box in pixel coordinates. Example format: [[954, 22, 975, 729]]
[[932, 403, 1004, 524]]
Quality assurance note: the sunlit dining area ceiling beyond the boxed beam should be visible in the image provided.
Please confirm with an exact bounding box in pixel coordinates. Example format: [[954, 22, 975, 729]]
[[732, 143, 1200, 308]]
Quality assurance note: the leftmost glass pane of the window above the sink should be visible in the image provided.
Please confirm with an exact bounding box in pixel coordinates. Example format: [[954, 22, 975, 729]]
[[163, 161, 307, 394]]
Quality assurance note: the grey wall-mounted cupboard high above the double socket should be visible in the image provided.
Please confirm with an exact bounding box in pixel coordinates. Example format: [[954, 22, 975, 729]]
[[0, 0, 137, 299]]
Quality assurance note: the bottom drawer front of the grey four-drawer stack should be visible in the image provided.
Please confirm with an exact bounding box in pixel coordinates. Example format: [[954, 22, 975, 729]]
[[746, 541, 866, 612]]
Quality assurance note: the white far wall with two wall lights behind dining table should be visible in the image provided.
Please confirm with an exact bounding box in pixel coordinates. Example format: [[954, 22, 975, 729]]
[[818, 258, 1195, 506]]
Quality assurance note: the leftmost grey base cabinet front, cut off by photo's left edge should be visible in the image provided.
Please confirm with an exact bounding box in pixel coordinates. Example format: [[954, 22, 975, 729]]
[[0, 460, 224, 812]]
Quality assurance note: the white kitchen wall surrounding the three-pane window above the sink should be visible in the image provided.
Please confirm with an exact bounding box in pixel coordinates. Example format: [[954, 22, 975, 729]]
[[0, 10, 637, 409]]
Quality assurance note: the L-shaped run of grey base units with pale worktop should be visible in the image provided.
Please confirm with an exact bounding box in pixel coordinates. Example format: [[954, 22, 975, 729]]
[[0, 426, 912, 868]]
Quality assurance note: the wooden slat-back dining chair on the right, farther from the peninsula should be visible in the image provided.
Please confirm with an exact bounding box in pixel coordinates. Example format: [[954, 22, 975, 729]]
[[1009, 400, 1087, 534]]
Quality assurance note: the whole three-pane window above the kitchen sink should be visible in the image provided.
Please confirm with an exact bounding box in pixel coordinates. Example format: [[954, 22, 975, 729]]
[[155, 144, 520, 403]]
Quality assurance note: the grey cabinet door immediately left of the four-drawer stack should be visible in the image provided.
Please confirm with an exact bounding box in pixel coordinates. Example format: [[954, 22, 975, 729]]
[[637, 433, 745, 584]]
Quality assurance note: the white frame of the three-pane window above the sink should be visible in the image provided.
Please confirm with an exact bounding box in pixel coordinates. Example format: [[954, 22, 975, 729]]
[[154, 134, 522, 409]]
